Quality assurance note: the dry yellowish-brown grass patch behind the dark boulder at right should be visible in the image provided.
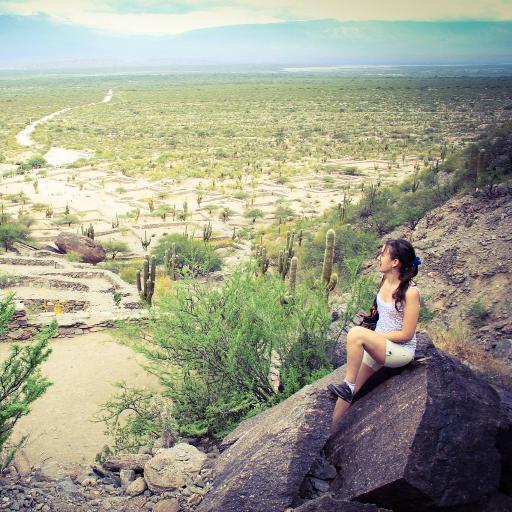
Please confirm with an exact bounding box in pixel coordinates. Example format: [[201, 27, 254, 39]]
[[428, 321, 512, 390]]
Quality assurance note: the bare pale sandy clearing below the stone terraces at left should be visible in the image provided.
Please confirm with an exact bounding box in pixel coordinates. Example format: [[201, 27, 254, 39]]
[[0, 331, 158, 477]]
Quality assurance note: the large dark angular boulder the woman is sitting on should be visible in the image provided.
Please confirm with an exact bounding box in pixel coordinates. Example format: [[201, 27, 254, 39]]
[[326, 348, 501, 512]]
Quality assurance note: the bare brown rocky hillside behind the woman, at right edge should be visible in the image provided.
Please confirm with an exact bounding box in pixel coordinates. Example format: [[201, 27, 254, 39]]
[[367, 185, 512, 363]]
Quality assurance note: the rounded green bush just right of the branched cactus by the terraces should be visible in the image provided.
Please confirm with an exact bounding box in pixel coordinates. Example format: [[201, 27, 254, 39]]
[[153, 234, 222, 277]]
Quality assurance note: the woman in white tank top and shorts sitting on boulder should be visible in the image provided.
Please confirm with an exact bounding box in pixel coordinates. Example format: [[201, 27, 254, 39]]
[[328, 238, 421, 432]]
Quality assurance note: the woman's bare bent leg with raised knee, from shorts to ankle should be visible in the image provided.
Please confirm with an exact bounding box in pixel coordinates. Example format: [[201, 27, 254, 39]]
[[345, 326, 387, 383]]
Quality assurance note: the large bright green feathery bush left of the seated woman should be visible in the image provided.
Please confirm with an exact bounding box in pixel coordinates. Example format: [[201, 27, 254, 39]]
[[116, 267, 332, 437]]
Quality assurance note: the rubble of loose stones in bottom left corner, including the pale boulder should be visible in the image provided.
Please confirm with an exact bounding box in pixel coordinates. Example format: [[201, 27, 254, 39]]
[[0, 436, 219, 512]]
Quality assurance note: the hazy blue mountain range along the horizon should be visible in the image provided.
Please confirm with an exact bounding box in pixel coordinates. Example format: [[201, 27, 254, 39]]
[[0, 15, 512, 69]]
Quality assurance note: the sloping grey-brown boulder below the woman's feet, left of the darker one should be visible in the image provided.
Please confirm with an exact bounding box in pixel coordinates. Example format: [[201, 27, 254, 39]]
[[197, 368, 345, 512]]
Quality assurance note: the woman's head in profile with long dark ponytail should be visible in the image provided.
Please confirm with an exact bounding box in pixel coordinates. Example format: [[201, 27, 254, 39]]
[[379, 238, 418, 310]]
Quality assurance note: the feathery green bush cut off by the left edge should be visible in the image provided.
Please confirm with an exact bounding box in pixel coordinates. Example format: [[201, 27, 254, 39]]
[[0, 295, 57, 471]]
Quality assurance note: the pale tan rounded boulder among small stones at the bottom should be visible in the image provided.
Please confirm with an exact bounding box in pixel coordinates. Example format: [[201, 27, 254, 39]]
[[144, 443, 207, 493]]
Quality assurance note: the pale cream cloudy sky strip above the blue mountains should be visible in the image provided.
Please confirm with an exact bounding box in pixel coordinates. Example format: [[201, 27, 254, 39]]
[[0, 0, 512, 35]]
